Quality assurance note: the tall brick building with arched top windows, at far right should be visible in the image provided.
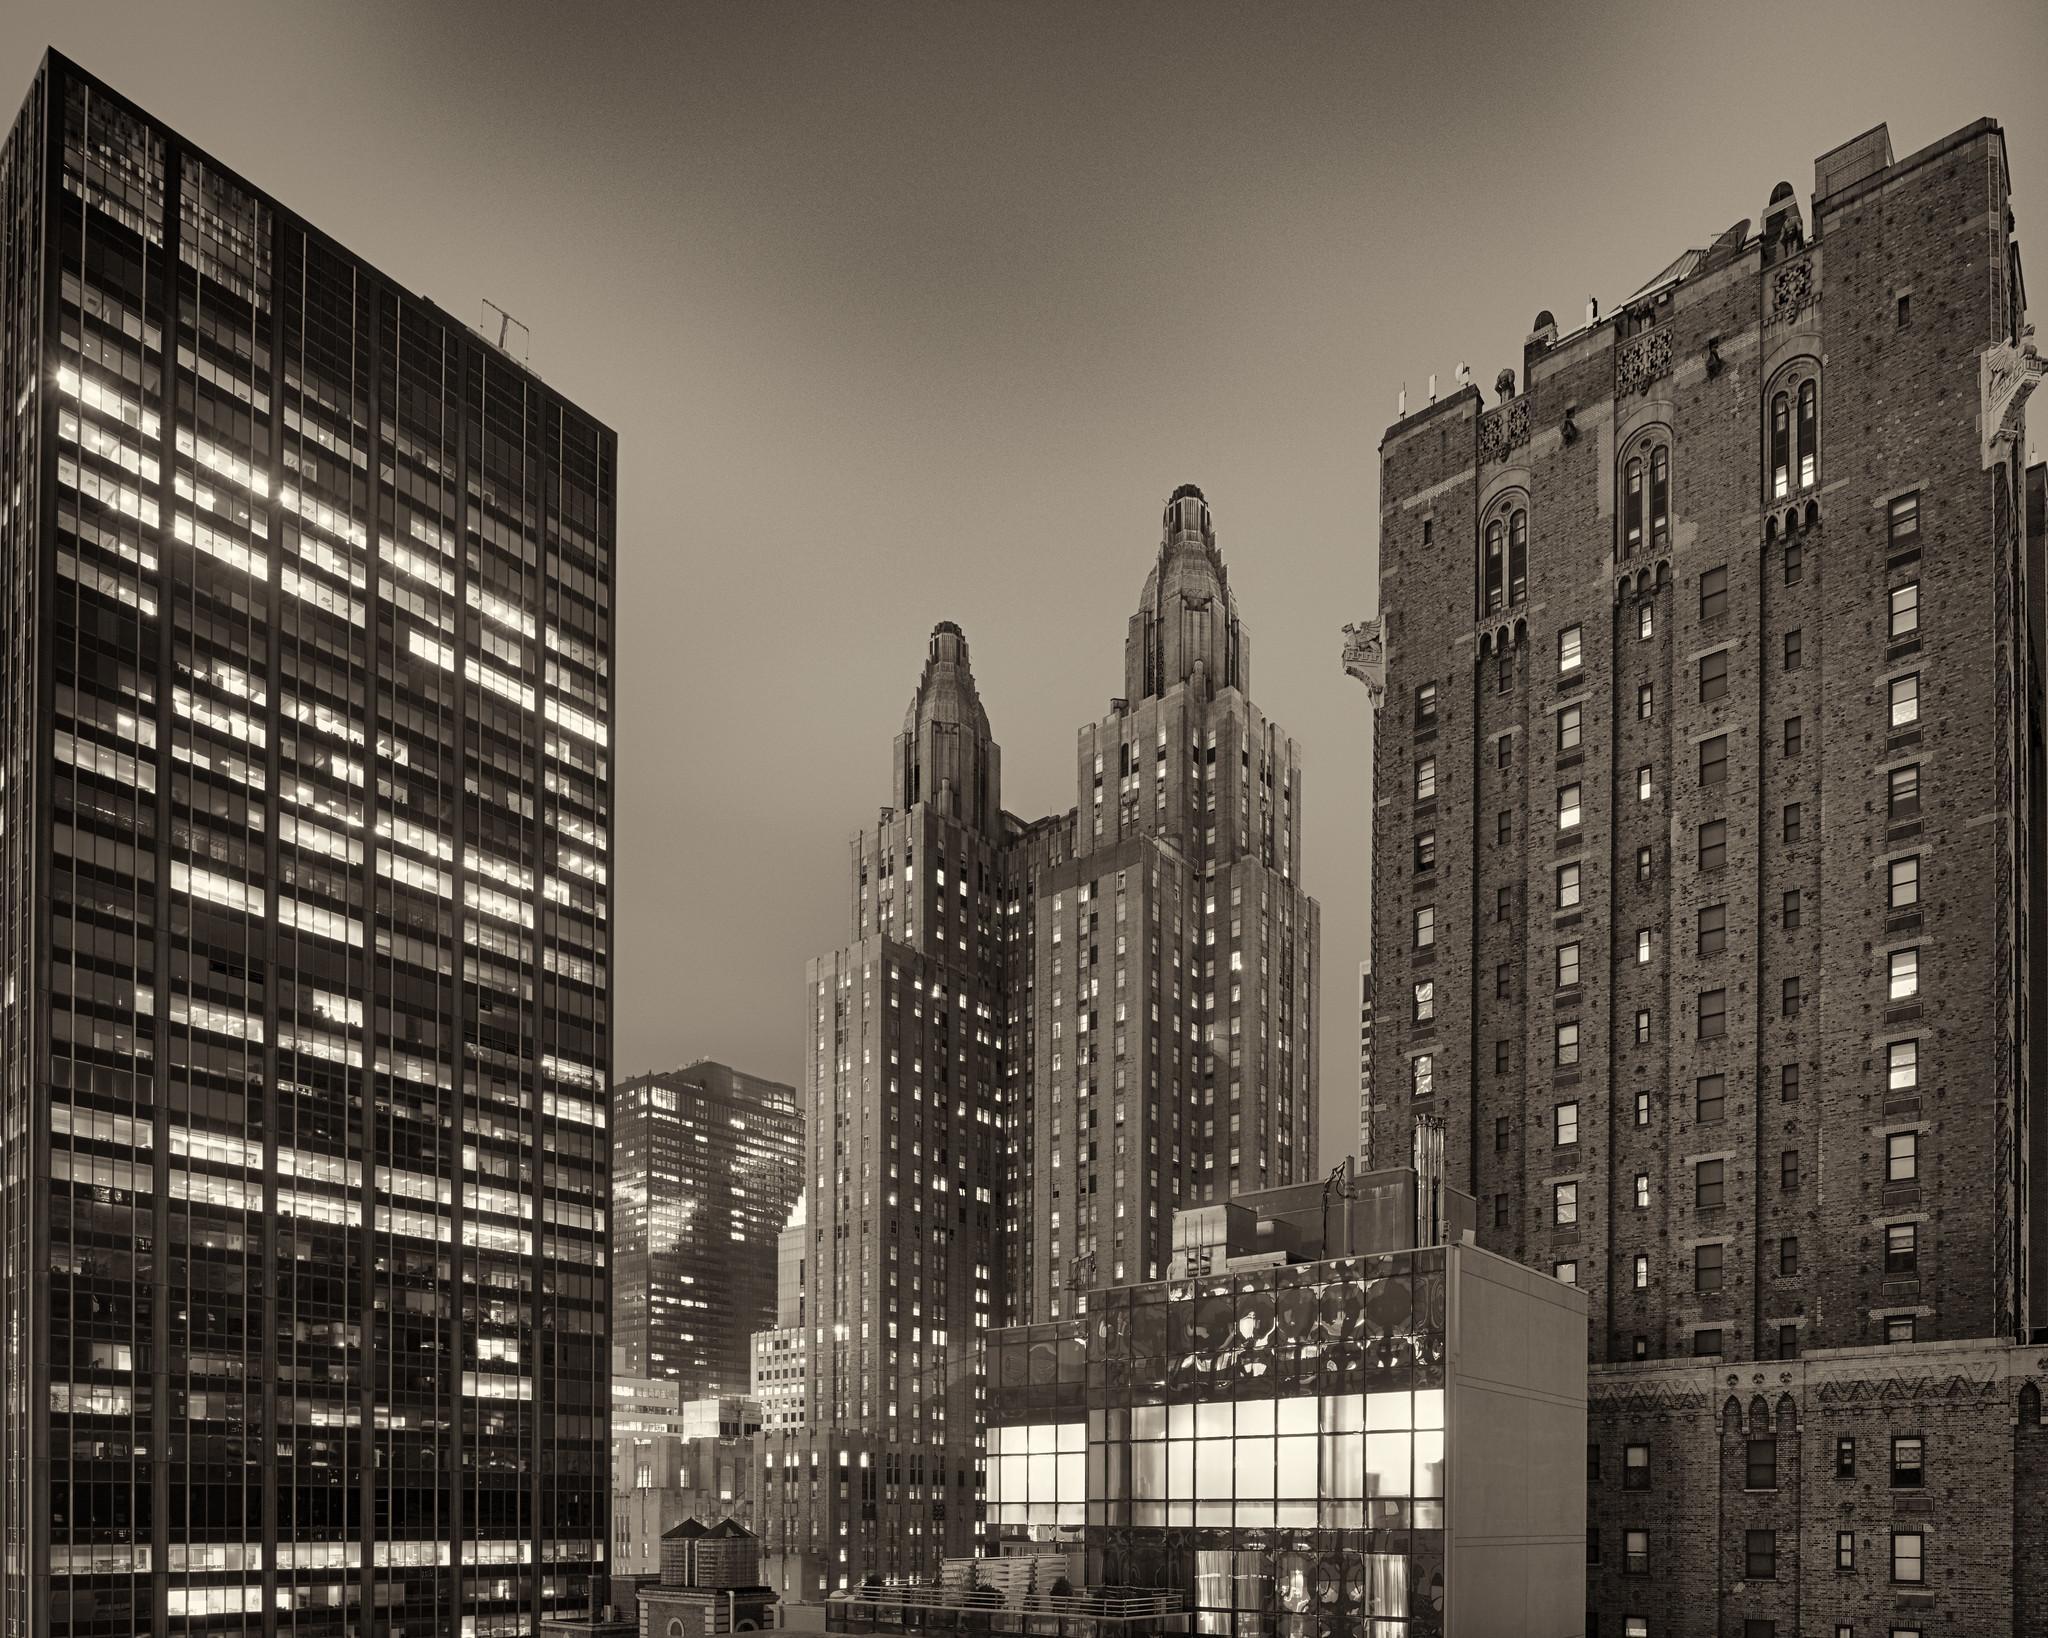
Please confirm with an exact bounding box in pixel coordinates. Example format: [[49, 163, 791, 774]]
[[1346, 121, 2048, 1638]]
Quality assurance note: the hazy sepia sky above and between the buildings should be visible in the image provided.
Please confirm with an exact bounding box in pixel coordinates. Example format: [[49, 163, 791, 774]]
[[0, 0, 2048, 1161]]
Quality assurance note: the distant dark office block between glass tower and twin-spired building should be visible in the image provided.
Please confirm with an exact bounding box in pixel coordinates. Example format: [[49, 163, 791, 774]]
[[612, 1061, 803, 1400]]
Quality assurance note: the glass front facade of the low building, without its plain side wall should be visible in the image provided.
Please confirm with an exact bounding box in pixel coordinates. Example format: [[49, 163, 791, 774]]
[[985, 1247, 1448, 1638]]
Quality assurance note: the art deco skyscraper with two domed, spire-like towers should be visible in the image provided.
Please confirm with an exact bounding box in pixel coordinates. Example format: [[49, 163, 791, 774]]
[[762, 485, 1319, 1595]]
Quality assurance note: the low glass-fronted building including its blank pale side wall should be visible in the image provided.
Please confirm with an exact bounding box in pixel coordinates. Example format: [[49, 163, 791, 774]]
[[983, 1171, 1585, 1638]]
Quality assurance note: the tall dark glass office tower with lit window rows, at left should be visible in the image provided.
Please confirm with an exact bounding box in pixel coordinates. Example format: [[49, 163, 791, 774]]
[[0, 55, 616, 1638]]
